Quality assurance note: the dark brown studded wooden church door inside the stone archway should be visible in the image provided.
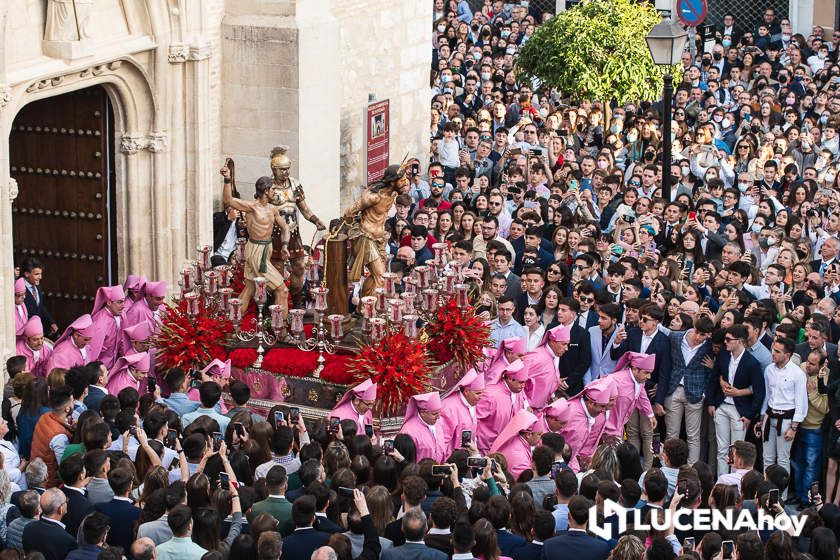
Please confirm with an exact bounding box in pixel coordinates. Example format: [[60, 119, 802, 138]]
[[9, 86, 118, 329]]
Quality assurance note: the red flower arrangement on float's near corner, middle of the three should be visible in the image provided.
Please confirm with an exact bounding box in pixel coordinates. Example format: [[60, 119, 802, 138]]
[[347, 332, 433, 414]]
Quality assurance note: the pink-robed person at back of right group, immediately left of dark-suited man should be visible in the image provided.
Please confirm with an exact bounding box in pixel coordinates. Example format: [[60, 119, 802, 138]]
[[522, 325, 572, 410]]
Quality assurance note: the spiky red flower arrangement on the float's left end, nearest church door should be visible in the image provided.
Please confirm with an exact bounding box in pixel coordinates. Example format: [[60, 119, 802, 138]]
[[154, 300, 233, 371]]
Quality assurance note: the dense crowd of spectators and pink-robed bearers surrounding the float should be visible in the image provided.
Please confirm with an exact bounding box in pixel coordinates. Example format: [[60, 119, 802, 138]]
[[0, 0, 840, 560]]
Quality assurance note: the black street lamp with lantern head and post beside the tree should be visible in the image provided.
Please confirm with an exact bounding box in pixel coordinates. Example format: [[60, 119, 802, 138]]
[[645, 11, 688, 203]]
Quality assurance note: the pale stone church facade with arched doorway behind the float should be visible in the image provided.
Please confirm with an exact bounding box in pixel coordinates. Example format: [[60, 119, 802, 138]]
[[0, 0, 431, 357]]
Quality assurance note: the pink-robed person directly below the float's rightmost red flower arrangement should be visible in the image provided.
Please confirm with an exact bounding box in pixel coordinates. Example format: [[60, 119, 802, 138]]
[[438, 369, 485, 457]]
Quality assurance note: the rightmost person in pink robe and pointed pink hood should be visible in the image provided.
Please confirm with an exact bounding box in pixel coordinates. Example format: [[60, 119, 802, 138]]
[[604, 352, 656, 442]]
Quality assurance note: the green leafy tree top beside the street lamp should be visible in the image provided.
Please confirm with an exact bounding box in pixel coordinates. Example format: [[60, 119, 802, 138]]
[[516, 0, 679, 104]]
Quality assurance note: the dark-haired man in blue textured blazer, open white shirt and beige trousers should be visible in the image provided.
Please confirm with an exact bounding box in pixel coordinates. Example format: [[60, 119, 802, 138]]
[[653, 315, 715, 465]]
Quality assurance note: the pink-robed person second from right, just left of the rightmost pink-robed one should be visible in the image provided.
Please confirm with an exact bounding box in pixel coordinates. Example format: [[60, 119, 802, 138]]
[[560, 375, 616, 472]]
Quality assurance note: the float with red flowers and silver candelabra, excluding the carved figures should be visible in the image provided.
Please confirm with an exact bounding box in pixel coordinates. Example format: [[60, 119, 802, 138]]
[[155, 160, 489, 433]]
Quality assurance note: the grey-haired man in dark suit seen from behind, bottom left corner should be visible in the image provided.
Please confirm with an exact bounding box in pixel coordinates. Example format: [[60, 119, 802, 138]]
[[23, 488, 78, 560]]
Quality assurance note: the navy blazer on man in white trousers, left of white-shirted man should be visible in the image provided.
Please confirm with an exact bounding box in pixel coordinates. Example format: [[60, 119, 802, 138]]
[[706, 350, 765, 420]]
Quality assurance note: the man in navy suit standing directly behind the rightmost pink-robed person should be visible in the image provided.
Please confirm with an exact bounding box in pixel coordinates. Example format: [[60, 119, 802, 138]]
[[610, 303, 671, 469]]
